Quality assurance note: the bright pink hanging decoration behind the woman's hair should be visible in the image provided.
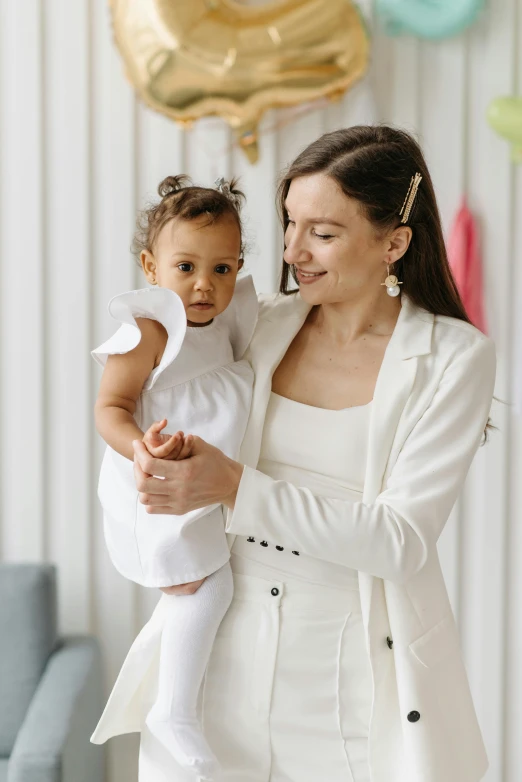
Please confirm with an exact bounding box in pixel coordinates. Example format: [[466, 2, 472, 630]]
[[448, 199, 487, 334]]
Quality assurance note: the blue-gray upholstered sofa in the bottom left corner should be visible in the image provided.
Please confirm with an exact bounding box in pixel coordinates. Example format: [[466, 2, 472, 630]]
[[0, 564, 105, 782]]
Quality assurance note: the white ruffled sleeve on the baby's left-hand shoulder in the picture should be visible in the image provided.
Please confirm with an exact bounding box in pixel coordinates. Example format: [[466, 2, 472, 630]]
[[91, 288, 187, 389]]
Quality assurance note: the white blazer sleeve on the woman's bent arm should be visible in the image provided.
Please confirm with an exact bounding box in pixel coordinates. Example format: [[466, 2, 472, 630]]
[[226, 338, 495, 583]]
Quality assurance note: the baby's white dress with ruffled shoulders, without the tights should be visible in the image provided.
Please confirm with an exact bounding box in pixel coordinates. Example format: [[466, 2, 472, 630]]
[[92, 275, 258, 587]]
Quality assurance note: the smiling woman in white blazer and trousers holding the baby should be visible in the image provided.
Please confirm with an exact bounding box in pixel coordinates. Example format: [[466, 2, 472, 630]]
[[91, 126, 495, 782]]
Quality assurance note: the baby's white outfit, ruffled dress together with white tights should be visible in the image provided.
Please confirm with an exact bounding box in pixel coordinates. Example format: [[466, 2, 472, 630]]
[[91, 277, 258, 780]]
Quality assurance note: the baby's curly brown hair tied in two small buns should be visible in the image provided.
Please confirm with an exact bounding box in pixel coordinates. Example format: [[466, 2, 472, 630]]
[[132, 174, 245, 265]]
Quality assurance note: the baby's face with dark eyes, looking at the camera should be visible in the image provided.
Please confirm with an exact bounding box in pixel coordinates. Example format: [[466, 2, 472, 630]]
[[141, 215, 243, 326]]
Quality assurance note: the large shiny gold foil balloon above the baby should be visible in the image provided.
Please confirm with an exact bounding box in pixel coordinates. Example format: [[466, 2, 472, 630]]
[[107, 0, 369, 162]]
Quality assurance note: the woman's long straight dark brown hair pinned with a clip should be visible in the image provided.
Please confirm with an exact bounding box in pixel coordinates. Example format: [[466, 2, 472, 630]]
[[277, 125, 495, 438]]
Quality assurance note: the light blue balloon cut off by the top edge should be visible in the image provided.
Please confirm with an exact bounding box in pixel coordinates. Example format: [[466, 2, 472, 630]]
[[376, 0, 485, 40]]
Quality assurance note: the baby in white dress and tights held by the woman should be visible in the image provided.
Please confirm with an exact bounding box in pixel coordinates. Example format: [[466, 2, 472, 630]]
[[93, 176, 257, 779]]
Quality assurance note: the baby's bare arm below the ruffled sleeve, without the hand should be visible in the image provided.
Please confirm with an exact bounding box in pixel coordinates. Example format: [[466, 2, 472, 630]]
[[94, 318, 167, 461]]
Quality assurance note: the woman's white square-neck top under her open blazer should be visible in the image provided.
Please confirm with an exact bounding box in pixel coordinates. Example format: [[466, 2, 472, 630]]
[[232, 392, 372, 589]]
